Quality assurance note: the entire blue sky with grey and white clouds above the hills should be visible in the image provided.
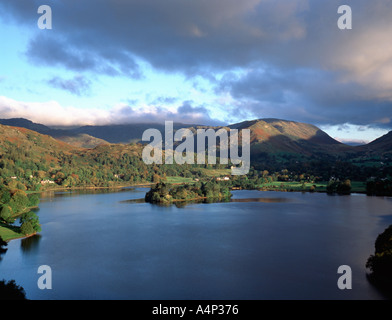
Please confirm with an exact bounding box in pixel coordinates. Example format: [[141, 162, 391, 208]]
[[0, 0, 392, 141]]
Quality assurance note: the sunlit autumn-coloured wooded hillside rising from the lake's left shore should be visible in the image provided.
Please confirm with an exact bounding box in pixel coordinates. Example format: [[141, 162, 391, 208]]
[[0, 125, 205, 190]]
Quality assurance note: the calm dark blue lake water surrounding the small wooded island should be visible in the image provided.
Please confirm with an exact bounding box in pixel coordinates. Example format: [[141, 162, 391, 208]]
[[0, 188, 392, 300]]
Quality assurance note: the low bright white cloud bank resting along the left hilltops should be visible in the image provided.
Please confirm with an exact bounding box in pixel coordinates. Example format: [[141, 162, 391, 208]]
[[0, 96, 219, 126]]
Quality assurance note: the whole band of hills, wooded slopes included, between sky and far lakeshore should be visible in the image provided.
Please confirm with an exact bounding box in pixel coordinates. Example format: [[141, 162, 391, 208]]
[[0, 119, 392, 188]]
